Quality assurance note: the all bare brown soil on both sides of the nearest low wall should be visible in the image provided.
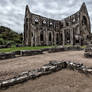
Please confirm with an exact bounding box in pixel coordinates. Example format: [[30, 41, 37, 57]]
[[0, 51, 92, 92]]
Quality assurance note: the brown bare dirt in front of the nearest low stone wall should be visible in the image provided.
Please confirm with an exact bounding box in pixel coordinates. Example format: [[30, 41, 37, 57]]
[[0, 70, 92, 92]]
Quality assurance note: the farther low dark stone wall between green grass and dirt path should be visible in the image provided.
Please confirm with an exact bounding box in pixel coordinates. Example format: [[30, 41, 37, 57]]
[[0, 47, 83, 60]]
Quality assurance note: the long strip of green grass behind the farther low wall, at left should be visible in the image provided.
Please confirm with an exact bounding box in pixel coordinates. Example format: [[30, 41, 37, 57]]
[[0, 46, 54, 53]]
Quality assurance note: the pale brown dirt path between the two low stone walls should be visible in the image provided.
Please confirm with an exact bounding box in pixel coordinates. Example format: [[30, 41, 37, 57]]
[[0, 51, 92, 80]]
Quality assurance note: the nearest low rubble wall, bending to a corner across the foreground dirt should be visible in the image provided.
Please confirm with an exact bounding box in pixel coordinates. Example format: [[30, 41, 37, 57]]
[[0, 61, 92, 89]]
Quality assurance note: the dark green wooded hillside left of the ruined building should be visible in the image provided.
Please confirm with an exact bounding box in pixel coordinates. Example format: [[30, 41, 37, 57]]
[[0, 26, 23, 45]]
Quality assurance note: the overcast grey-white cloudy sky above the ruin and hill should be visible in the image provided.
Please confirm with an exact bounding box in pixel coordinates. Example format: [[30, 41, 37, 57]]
[[0, 0, 92, 33]]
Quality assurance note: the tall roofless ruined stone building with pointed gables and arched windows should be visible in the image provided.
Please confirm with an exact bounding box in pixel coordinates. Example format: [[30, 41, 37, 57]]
[[24, 3, 91, 46]]
